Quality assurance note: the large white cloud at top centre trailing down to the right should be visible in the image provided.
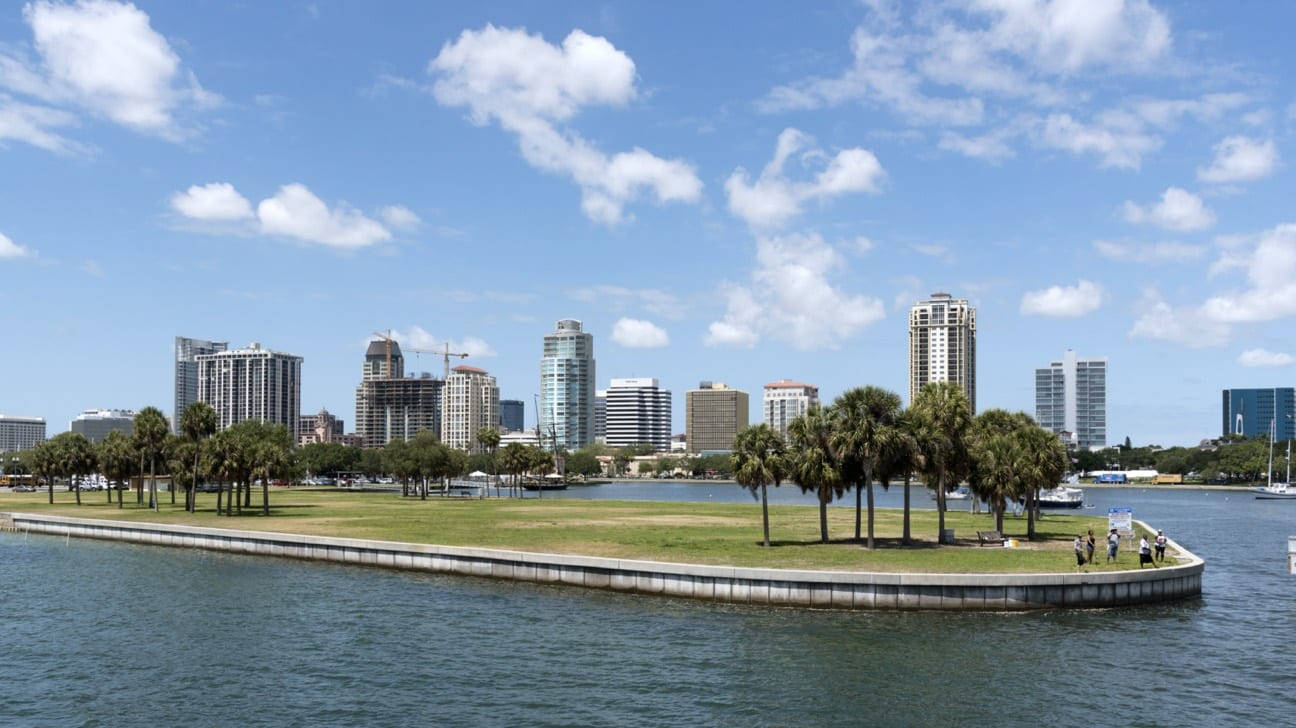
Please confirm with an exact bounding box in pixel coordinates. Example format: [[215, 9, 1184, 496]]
[[428, 25, 702, 224]]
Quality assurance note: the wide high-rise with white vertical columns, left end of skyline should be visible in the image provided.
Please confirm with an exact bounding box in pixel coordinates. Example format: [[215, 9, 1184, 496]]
[[194, 342, 302, 442]]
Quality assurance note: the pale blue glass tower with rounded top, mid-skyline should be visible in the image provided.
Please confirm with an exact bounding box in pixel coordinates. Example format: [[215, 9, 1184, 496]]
[[537, 319, 595, 449]]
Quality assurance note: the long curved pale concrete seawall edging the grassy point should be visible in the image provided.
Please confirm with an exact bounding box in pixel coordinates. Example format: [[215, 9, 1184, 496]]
[[0, 513, 1205, 611]]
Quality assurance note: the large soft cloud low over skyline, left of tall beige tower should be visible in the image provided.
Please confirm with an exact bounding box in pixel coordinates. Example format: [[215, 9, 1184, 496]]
[[706, 233, 885, 350]]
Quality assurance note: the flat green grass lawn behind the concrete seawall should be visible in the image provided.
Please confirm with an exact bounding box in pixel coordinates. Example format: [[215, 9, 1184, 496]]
[[0, 488, 1176, 573]]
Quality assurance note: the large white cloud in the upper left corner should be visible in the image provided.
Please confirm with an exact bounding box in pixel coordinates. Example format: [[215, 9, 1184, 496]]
[[0, 0, 219, 148]]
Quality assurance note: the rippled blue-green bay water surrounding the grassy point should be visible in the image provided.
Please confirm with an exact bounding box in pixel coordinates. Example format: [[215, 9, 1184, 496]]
[[0, 484, 1296, 727]]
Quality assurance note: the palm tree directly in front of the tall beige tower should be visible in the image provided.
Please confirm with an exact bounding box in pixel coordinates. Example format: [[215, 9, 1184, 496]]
[[912, 382, 972, 535]]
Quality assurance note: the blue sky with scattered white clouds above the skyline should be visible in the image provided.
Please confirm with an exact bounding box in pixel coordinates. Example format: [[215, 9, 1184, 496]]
[[0, 0, 1296, 444]]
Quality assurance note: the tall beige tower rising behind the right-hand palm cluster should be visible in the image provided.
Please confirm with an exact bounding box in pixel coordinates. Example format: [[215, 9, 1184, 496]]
[[908, 293, 976, 413]]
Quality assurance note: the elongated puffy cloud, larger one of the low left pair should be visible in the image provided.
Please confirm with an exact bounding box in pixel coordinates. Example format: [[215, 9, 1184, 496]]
[[257, 183, 391, 247]]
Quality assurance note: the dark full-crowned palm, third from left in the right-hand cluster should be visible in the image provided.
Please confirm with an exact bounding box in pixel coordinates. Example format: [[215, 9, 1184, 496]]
[[829, 386, 901, 548]]
